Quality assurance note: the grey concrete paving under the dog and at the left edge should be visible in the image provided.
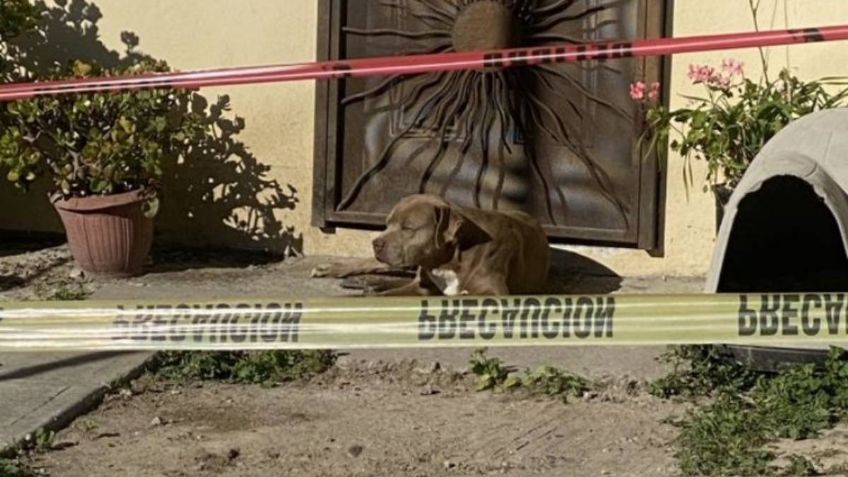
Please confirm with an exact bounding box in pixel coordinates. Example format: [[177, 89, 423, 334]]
[[0, 247, 703, 451]]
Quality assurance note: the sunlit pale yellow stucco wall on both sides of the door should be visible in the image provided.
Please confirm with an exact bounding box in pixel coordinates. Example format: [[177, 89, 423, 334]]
[[0, 0, 848, 275]]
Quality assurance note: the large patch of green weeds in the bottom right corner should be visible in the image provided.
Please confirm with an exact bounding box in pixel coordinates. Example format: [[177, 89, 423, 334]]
[[671, 348, 848, 476]]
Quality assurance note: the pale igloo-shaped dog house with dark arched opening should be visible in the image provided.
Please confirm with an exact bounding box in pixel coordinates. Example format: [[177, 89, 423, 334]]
[[707, 109, 848, 368]]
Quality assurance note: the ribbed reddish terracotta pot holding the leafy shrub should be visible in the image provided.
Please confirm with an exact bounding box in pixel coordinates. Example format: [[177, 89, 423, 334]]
[[51, 191, 153, 277]]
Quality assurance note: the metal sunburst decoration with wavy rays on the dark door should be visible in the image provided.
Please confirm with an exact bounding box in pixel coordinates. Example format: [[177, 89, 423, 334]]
[[339, 0, 631, 224]]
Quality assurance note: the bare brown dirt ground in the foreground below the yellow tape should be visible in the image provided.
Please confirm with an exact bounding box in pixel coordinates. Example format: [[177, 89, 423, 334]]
[[28, 361, 683, 477]]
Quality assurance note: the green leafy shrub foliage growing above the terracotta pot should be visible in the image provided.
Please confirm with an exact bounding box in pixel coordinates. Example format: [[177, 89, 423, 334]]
[[0, 59, 206, 206]]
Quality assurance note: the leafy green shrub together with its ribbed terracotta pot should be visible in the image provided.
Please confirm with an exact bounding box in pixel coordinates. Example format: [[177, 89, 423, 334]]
[[0, 59, 204, 276]]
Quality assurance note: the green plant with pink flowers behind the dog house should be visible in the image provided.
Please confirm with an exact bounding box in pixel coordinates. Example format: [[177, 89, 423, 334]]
[[630, 59, 848, 190]]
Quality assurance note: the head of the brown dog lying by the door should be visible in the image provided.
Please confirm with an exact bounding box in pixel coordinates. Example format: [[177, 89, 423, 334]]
[[373, 195, 491, 268]]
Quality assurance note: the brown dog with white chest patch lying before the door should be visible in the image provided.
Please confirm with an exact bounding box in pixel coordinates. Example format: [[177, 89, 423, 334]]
[[313, 195, 550, 296]]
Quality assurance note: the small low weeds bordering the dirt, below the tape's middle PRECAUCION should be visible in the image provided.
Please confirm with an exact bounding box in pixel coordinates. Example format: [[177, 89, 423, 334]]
[[471, 349, 589, 402]]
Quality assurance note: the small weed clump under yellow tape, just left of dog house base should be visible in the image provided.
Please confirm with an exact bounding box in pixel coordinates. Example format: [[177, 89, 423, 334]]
[[650, 346, 757, 399]]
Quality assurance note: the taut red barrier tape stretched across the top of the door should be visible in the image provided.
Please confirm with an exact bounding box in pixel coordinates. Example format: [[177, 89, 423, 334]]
[[0, 25, 848, 101]]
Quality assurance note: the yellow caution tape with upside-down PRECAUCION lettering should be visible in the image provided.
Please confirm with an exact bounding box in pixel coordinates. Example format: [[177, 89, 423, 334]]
[[0, 293, 848, 351]]
